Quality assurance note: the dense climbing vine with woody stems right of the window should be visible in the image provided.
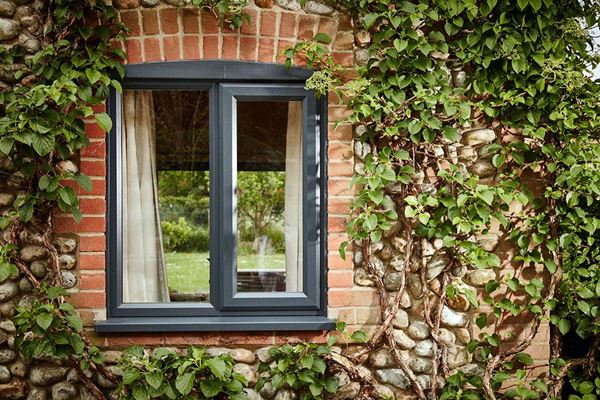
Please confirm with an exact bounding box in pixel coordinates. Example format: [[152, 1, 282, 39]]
[[288, 0, 600, 399]]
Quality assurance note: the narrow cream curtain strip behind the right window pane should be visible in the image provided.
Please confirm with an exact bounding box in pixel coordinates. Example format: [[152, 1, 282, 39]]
[[284, 101, 303, 292]]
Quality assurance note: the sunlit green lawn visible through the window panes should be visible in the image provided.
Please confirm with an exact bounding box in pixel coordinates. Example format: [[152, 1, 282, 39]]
[[165, 253, 285, 293]]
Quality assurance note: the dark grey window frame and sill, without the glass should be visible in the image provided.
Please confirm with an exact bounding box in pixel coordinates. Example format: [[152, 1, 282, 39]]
[[96, 61, 335, 332]]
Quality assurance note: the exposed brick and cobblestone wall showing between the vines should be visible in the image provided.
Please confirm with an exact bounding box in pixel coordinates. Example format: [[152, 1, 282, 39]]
[[0, 0, 548, 400]]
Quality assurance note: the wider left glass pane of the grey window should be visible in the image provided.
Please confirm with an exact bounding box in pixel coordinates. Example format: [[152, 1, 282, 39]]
[[122, 91, 210, 303]]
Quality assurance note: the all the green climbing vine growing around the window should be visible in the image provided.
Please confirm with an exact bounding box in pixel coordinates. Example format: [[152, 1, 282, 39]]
[[0, 0, 600, 400]]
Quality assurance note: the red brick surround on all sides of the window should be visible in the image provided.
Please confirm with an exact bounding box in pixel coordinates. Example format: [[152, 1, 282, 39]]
[[57, 2, 360, 346]]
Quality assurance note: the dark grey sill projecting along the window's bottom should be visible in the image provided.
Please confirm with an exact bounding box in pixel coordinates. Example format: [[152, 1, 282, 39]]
[[96, 316, 335, 333]]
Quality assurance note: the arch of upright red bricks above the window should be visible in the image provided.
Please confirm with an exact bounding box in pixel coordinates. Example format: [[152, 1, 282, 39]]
[[120, 5, 354, 67]]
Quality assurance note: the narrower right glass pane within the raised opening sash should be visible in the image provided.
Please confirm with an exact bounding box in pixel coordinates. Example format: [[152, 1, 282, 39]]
[[237, 101, 302, 292]]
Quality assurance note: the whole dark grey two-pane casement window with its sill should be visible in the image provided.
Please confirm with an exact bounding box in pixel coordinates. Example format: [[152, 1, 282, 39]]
[[96, 61, 332, 332]]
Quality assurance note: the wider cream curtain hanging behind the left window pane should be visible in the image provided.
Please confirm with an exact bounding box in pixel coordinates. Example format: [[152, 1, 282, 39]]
[[122, 91, 169, 303]]
